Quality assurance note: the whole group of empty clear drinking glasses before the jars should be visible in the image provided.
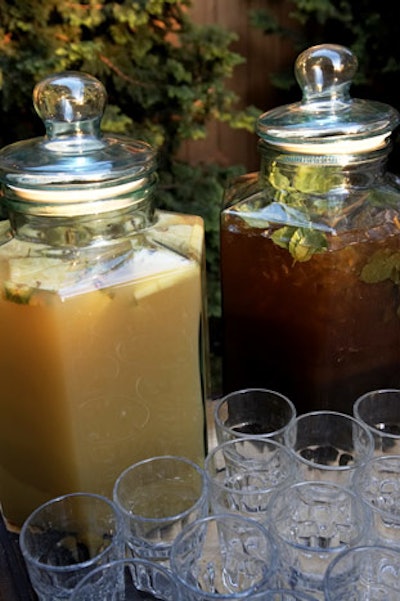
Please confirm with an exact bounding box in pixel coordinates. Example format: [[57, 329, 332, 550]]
[[20, 389, 400, 601]]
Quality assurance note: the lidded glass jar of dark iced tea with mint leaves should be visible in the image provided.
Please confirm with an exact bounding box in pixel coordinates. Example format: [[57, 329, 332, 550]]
[[221, 45, 400, 413]]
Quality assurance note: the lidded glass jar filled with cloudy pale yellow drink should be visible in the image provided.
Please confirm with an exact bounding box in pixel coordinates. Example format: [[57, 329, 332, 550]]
[[0, 72, 206, 525]]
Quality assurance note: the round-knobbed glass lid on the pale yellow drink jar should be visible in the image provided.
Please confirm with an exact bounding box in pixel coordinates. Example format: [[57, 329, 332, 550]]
[[0, 71, 156, 214]]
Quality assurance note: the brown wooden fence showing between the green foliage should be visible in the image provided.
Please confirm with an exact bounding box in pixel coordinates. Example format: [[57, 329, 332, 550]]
[[181, 0, 295, 170]]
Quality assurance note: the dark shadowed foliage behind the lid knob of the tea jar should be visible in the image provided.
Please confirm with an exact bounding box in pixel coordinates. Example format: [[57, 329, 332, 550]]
[[250, 0, 400, 108]]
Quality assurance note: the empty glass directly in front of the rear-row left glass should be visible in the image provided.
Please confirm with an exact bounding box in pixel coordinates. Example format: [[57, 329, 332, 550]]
[[204, 436, 295, 522]]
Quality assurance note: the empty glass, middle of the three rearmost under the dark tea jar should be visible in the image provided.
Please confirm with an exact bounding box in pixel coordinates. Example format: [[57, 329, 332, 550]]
[[285, 411, 374, 486]]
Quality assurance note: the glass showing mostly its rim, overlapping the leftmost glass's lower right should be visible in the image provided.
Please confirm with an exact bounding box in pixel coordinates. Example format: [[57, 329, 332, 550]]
[[71, 558, 183, 601]]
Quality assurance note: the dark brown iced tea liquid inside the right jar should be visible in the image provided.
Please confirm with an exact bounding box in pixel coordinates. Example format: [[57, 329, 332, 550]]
[[221, 213, 400, 413]]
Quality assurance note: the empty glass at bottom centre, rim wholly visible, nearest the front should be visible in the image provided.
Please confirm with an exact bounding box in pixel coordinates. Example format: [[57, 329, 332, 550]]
[[171, 513, 277, 601]]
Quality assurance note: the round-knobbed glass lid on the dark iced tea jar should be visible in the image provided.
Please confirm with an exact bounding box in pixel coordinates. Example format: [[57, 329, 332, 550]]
[[257, 44, 400, 154]]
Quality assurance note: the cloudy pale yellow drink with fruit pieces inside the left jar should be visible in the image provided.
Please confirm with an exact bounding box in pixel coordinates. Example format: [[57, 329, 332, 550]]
[[0, 217, 205, 525]]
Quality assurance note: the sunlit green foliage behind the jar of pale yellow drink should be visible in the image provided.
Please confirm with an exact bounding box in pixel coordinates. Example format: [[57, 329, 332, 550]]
[[0, 0, 258, 314]]
